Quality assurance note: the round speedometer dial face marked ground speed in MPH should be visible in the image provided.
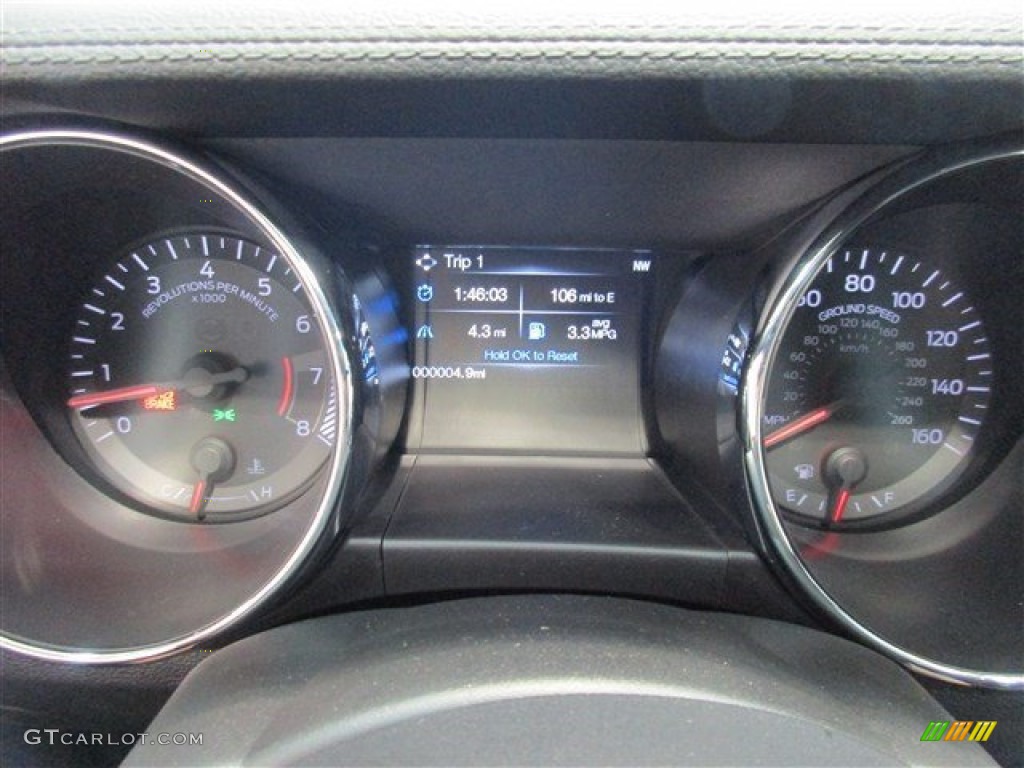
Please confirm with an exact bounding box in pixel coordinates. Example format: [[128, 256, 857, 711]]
[[762, 248, 993, 526]]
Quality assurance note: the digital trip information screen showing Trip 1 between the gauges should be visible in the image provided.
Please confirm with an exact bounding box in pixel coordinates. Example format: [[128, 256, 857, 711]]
[[413, 246, 654, 454]]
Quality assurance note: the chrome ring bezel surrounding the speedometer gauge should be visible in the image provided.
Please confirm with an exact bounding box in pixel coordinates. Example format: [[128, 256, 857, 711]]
[[738, 143, 1024, 690]]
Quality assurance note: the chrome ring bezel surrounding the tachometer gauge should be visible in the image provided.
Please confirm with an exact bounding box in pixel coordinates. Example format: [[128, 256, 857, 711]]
[[0, 128, 356, 665]]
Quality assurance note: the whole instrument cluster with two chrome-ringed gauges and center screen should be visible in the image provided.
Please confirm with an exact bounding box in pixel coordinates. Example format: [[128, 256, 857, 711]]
[[0, 129, 1024, 688]]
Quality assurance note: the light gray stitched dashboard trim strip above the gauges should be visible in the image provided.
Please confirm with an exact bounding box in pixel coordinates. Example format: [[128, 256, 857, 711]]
[[5, 5, 1020, 82]]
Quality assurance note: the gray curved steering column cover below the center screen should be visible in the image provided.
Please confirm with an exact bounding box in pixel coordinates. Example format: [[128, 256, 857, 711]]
[[125, 595, 990, 766]]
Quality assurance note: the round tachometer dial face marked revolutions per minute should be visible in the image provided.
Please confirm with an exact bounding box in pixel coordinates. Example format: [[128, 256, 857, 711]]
[[67, 232, 339, 521]]
